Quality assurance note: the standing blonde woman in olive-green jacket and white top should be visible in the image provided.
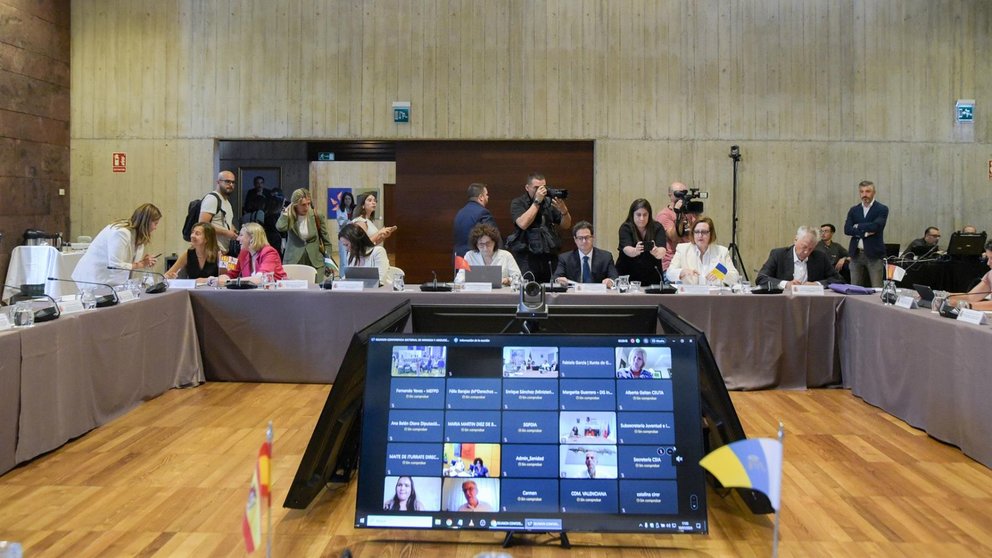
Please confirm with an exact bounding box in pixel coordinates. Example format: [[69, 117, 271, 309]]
[[276, 188, 331, 271]]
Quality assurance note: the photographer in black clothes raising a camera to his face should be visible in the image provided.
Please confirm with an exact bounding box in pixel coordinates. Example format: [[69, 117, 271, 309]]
[[506, 173, 572, 283]]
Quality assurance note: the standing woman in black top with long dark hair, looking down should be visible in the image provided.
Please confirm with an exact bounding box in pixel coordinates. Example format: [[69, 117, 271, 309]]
[[617, 198, 666, 285]]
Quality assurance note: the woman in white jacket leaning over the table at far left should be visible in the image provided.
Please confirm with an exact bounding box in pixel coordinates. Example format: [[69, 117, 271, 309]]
[[72, 203, 162, 285]]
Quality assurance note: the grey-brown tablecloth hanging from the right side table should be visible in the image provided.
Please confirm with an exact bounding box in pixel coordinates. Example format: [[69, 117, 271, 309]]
[[839, 296, 992, 467]]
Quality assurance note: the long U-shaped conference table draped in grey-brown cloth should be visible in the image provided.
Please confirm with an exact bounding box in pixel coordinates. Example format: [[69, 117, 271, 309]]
[[0, 288, 992, 474]]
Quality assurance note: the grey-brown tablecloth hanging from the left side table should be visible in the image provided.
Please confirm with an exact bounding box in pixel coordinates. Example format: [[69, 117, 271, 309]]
[[13, 291, 204, 463]]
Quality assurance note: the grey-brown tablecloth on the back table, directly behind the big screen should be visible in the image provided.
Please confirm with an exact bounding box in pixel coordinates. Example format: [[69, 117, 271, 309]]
[[190, 289, 844, 389]]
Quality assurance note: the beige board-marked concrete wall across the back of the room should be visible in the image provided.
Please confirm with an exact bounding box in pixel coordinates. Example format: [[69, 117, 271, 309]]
[[70, 0, 992, 270]]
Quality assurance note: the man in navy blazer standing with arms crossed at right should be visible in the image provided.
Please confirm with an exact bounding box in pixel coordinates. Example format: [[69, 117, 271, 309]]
[[844, 180, 889, 287]]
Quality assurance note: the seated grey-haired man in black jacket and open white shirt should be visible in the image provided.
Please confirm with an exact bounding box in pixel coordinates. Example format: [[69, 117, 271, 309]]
[[756, 226, 843, 289]]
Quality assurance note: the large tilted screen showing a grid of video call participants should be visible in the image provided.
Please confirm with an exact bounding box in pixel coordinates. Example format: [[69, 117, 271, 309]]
[[355, 334, 707, 533]]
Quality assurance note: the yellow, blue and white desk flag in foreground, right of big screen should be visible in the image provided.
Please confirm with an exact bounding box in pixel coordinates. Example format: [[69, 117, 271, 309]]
[[699, 438, 782, 511]]
